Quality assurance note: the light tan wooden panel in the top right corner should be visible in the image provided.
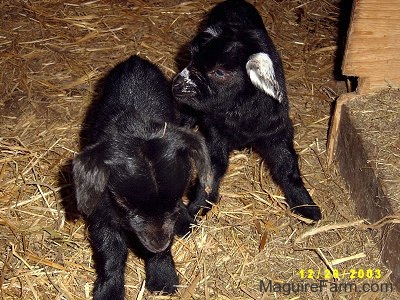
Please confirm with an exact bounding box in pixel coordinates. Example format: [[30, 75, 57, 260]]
[[342, 0, 400, 94]]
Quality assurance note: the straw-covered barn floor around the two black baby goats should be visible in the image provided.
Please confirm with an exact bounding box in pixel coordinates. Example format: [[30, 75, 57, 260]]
[[0, 0, 400, 300]]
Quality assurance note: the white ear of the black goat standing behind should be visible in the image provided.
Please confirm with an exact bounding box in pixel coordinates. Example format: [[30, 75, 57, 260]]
[[246, 52, 283, 102]]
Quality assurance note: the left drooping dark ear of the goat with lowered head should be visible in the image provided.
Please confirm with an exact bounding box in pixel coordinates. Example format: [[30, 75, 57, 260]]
[[73, 145, 109, 216]]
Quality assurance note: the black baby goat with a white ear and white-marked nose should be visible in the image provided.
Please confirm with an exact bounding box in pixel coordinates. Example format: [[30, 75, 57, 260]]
[[173, 0, 321, 220]]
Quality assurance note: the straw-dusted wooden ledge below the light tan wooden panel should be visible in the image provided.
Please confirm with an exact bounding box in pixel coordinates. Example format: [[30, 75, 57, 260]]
[[336, 91, 400, 288]]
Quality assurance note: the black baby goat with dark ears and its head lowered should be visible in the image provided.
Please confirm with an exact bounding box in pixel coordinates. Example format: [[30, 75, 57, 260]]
[[73, 56, 211, 300]]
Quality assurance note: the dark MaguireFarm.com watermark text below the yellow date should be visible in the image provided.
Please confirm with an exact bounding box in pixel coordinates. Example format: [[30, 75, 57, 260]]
[[260, 280, 394, 296]]
